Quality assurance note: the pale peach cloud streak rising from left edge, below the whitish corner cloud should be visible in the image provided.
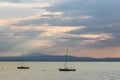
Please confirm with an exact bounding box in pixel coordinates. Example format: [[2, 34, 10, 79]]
[[0, 10, 64, 26]]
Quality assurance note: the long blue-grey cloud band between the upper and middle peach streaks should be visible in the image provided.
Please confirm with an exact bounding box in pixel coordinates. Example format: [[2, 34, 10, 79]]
[[14, 17, 82, 26]]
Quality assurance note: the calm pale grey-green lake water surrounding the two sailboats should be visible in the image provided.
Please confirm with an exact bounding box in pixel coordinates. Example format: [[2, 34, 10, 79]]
[[0, 62, 120, 80]]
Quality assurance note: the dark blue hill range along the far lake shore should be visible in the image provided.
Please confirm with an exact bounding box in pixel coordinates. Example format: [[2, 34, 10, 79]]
[[0, 53, 120, 62]]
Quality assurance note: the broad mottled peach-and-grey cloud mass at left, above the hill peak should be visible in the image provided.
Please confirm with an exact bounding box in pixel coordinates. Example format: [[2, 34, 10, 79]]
[[0, 18, 85, 52]]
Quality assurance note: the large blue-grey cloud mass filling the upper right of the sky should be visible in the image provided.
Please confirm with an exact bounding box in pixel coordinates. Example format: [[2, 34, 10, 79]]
[[48, 0, 120, 48]]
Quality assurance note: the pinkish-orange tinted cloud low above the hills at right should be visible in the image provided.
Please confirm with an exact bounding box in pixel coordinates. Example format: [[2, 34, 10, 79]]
[[75, 47, 120, 58]]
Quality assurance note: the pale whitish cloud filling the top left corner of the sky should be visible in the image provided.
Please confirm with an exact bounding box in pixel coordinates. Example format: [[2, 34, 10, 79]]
[[0, 1, 56, 19]]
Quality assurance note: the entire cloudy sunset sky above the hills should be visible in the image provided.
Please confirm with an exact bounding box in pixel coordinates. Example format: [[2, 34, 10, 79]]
[[0, 0, 120, 58]]
